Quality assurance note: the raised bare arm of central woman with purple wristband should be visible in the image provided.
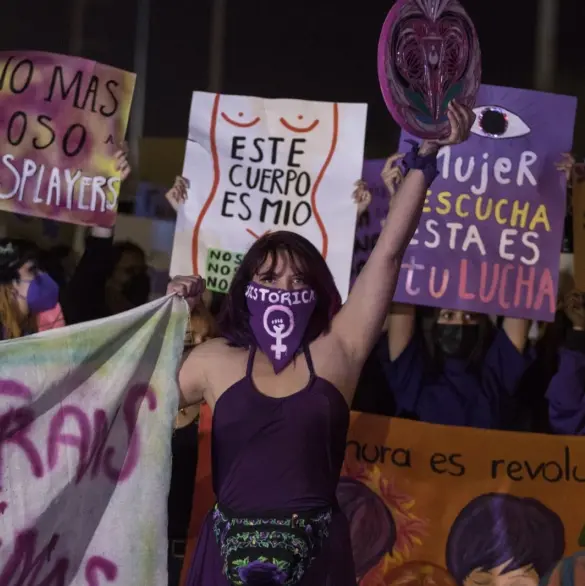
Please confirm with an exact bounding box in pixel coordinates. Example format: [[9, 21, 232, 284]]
[[331, 102, 475, 367]]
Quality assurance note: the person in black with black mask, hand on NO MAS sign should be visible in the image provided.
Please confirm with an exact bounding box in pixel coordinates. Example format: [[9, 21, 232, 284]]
[[62, 149, 150, 324]]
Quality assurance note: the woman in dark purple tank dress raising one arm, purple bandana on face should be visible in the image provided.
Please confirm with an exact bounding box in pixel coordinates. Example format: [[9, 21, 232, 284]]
[[169, 103, 474, 586]]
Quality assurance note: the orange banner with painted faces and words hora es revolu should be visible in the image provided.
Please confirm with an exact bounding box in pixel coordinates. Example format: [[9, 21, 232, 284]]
[[189, 412, 585, 586]]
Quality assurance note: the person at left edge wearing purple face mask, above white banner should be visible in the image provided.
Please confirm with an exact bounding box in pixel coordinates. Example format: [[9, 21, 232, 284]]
[[0, 238, 64, 340]]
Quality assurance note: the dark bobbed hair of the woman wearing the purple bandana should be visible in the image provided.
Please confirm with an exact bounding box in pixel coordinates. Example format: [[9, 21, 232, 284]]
[[218, 231, 341, 348]]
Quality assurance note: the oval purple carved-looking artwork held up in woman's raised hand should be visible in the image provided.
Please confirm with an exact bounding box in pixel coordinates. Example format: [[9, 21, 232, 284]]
[[378, 0, 481, 139]]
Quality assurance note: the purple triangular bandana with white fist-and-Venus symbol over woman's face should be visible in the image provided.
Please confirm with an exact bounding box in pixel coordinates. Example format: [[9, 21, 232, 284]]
[[246, 283, 317, 374]]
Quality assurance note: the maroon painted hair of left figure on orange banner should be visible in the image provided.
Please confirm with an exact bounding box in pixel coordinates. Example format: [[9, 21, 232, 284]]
[[336, 476, 396, 580]]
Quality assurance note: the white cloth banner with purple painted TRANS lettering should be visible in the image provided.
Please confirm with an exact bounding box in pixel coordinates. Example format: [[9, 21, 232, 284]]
[[0, 298, 187, 586]]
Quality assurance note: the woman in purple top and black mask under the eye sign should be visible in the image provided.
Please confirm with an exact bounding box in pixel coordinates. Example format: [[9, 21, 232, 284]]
[[386, 298, 530, 429]]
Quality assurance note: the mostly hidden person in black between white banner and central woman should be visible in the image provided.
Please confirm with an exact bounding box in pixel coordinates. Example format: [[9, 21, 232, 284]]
[[168, 303, 218, 586]]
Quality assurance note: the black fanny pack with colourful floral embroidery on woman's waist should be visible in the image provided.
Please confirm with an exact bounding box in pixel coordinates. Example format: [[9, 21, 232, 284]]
[[213, 505, 332, 586]]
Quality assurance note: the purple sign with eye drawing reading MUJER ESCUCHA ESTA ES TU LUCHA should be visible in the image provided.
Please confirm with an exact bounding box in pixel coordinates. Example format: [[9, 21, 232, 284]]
[[395, 86, 577, 321]]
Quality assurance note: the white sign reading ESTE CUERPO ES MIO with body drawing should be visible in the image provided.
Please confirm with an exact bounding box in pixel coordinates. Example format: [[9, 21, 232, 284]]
[[171, 92, 367, 298]]
